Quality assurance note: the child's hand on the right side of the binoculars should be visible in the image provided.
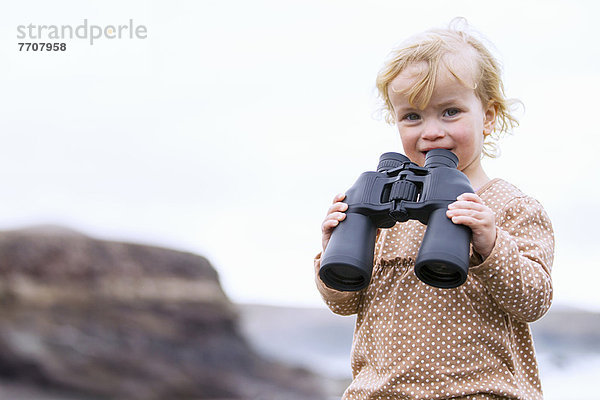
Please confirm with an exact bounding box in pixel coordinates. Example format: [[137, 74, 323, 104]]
[[446, 193, 496, 260]]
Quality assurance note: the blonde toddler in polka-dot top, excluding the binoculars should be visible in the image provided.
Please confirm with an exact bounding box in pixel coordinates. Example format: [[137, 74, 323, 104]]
[[315, 22, 554, 400]]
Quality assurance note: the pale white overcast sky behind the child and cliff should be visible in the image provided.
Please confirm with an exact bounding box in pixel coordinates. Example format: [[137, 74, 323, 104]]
[[0, 0, 600, 310]]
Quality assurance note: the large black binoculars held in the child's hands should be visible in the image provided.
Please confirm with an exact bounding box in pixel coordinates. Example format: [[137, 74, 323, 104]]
[[319, 149, 473, 291]]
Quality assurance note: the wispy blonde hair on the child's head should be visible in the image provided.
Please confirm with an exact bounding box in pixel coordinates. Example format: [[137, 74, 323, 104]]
[[377, 18, 520, 157]]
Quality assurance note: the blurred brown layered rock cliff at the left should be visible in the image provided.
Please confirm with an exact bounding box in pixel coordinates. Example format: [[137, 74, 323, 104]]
[[0, 227, 322, 400]]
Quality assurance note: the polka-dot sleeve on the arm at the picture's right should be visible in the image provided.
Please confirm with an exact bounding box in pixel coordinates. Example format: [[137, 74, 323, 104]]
[[471, 196, 554, 322]]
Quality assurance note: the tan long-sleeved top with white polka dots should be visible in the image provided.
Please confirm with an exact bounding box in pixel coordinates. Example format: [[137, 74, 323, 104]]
[[315, 179, 554, 400]]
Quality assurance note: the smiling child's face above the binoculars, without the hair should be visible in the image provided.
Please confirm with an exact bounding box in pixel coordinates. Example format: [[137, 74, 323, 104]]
[[388, 63, 496, 177]]
